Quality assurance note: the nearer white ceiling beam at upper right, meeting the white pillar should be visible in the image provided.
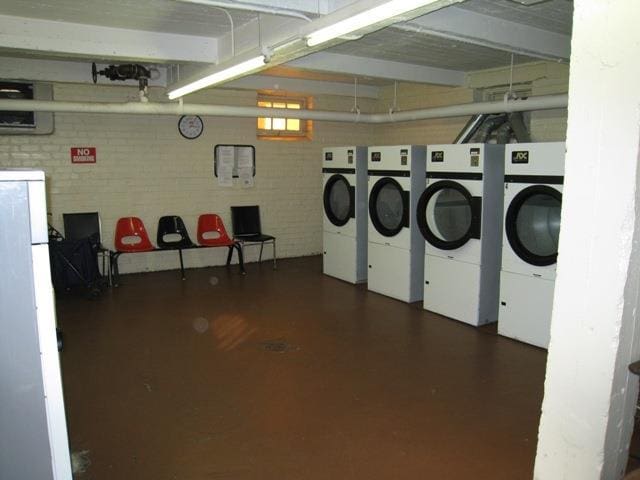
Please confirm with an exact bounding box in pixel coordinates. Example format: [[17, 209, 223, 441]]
[[394, 6, 571, 61]]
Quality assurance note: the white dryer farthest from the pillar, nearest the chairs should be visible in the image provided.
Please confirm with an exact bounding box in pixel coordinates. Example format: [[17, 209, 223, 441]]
[[322, 147, 367, 283]]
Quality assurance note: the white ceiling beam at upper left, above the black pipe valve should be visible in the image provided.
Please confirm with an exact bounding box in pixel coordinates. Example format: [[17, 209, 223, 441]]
[[0, 15, 218, 63]]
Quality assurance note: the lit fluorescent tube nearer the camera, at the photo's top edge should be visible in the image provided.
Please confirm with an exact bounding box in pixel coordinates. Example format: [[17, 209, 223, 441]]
[[307, 0, 436, 47]]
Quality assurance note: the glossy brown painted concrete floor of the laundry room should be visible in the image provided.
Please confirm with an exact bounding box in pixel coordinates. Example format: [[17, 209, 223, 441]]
[[58, 257, 546, 480]]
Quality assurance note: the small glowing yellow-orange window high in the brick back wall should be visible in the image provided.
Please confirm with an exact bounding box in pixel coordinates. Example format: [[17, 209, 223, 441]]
[[257, 95, 312, 140]]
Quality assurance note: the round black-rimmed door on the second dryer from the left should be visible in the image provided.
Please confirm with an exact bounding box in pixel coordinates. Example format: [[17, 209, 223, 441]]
[[369, 177, 409, 237]]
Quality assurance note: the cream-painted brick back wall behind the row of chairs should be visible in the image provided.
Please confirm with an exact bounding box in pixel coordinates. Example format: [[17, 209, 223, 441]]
[[0, 84, 375, 273]]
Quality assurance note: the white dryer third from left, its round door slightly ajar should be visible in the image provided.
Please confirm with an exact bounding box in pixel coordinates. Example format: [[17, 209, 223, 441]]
[[416, 144, 504, 326]]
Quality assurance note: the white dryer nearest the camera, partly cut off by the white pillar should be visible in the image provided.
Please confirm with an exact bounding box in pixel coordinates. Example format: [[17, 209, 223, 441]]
[[498, 142, 565, 348]]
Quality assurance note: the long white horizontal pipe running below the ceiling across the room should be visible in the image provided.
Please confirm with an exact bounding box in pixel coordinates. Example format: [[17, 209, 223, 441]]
[[0, 95, 567, 124]]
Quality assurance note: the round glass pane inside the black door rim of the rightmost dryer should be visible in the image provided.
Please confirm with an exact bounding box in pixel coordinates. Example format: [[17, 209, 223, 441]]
[[516, 194, 562, 257]]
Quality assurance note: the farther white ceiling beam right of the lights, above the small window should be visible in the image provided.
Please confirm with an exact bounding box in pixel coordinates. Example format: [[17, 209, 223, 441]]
[[287, 52, 465, 86]]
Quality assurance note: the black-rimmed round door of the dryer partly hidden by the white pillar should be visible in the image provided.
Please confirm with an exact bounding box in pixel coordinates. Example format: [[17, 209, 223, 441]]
[[505, 185, 562, 266]]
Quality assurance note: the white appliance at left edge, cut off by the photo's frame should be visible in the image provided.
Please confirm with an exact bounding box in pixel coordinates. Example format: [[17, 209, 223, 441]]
[[0, 170, 72, 480]]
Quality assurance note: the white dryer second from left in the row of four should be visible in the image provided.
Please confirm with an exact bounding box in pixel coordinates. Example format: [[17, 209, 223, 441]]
[[368, 145, 426, 302]]
